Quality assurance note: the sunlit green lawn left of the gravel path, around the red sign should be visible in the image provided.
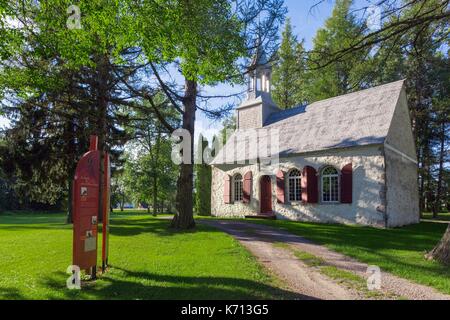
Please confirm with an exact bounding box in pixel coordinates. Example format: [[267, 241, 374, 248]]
[[0, 214, 292, 299]]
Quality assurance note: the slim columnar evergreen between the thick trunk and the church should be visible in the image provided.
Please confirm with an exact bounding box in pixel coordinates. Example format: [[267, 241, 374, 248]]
[[194, 135, 211, 216]]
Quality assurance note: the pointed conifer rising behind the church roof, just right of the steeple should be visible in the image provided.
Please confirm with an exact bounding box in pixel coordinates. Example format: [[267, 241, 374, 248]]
[[272, 19, 306, 109]]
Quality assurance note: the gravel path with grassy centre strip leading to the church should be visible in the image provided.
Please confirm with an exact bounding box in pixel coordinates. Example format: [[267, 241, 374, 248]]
[[199, 220, 450, 300]]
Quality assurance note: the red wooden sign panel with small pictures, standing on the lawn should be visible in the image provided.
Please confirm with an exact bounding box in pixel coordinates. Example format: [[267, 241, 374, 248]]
[[72, 136, 100, 277]]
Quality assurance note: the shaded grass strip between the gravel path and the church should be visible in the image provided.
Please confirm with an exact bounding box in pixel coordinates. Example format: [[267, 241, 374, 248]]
[[229, 220, 450, 294]]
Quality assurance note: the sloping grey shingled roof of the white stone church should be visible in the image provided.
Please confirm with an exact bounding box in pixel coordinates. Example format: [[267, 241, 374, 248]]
[[212, 80, 404, 164]]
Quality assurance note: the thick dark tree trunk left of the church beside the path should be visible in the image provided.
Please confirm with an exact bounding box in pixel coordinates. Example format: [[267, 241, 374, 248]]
[[171, 80, 197, 229]]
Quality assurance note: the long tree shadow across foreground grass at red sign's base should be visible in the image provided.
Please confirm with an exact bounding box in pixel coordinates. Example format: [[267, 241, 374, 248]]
[[43, 268, 314, 300]]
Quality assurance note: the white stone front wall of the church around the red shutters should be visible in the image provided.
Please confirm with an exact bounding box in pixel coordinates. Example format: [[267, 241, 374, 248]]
[[211, 145, 386, 227]]
